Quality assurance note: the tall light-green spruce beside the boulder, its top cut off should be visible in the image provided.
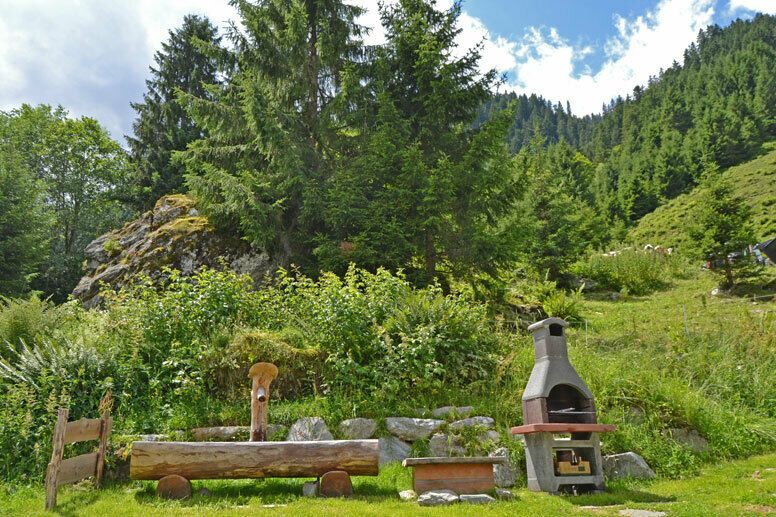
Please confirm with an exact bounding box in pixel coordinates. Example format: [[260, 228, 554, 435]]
[[182, 0, 362, 265]]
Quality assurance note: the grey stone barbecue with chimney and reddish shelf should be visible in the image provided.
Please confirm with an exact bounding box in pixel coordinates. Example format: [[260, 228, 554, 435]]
[[512, 318, 614, 493]]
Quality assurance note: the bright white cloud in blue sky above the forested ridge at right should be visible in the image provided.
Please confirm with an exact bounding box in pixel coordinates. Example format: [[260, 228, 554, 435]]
[[511, 0, 716, 115]]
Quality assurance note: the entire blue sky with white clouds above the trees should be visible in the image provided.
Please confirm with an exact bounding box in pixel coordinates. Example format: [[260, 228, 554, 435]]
[[0, 0, 776, 144]]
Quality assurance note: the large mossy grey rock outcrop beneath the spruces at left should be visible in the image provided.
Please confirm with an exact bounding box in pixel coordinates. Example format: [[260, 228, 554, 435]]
[[73, 194, 274, 307]]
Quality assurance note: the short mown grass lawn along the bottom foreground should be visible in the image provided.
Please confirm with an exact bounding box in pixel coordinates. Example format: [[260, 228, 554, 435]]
[[0, 454, 776, 516]]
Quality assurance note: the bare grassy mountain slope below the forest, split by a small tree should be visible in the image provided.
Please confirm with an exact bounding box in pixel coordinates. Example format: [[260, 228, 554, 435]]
[[627, 141, 776, 248]]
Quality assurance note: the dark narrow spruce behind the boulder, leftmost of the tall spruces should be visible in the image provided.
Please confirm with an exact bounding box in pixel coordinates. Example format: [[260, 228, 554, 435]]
[[127, 15, 220, 209]]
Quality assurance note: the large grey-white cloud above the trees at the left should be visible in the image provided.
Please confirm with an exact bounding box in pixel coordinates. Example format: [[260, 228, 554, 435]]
[[0, 0, 234, 140]]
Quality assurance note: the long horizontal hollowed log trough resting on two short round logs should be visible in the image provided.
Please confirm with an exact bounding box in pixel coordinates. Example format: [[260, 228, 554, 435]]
[[129, 440, 380, 480]]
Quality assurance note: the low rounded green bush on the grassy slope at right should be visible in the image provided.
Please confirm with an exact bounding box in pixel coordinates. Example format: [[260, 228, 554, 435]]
[[574, 249, 677, 296]]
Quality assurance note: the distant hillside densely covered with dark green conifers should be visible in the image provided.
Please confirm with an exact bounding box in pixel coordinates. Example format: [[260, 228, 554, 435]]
[[486, 15, 776, 225]]
